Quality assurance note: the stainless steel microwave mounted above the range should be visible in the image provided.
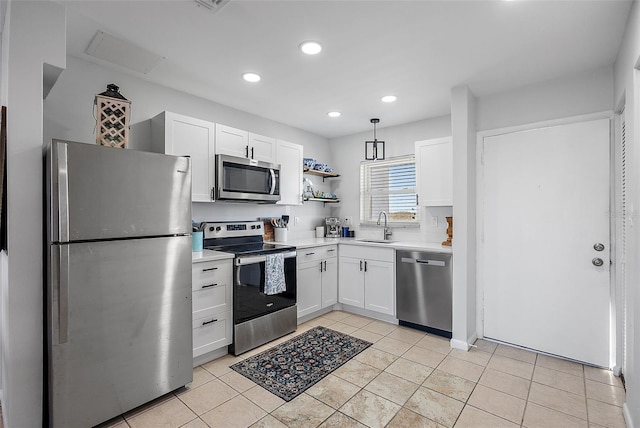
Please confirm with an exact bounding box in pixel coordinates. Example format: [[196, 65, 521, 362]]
[[215, 155, 280, 204]]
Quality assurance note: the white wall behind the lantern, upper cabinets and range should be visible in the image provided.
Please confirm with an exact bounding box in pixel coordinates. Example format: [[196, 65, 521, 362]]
[[44, 57, 331, 238]]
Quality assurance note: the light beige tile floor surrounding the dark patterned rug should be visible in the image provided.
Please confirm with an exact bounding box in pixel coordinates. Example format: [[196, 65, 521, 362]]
[[97, 311, 625, 428]]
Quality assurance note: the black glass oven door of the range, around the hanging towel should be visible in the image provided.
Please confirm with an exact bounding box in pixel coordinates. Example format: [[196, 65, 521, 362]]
[[233, 251, 297, 324]]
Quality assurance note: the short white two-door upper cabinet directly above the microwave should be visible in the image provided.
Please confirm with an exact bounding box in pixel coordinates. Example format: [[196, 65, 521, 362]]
[[216, 124, 276, 163]]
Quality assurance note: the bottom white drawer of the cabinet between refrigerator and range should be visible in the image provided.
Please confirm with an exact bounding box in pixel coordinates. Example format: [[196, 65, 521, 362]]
[[193, 312, 233, 358]]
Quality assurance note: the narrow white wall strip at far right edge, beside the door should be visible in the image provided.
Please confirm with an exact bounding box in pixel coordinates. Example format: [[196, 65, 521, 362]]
[[614, 1, 640, 427]]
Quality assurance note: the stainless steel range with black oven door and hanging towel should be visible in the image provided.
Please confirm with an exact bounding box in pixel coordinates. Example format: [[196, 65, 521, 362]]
[[204, 221, 298, 355]]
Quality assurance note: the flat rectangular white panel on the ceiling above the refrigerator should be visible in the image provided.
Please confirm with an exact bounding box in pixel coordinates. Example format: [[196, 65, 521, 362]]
[[85, 31, 165, 74]]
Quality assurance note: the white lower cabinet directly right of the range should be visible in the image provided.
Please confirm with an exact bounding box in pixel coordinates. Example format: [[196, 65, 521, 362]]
[[297, 245, 338, 318]]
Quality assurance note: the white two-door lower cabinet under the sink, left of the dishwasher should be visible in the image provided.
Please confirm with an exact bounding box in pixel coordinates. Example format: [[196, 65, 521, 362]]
[[338, 245, 395, 315]]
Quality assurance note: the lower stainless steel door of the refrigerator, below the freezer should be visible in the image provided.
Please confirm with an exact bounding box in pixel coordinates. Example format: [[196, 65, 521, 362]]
[[47, 236, 193, 427]]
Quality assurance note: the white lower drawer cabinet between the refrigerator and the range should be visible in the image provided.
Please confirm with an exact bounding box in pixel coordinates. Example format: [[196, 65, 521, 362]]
[[191, 259, 233, 358]]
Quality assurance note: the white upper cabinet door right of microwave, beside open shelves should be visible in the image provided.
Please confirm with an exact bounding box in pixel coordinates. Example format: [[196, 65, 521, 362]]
[[276, 140, 303, 205]]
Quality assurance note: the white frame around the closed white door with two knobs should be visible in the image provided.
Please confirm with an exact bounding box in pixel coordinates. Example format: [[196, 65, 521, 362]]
[[476, 110, 619, 362]]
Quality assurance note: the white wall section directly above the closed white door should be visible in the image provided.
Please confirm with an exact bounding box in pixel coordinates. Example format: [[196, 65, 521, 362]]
[[476, 67, 613, 131]]
